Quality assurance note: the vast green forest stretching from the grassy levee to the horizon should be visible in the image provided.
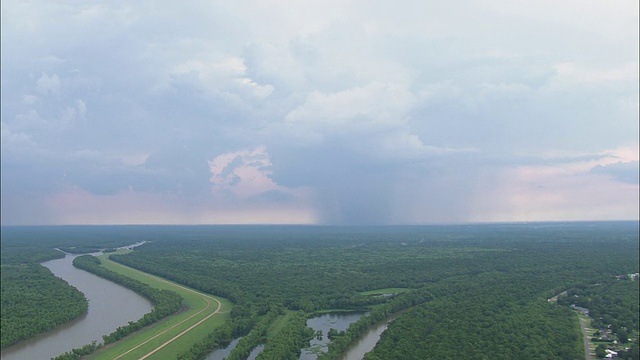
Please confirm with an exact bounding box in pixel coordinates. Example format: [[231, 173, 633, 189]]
[[3, 222, 639, 359]]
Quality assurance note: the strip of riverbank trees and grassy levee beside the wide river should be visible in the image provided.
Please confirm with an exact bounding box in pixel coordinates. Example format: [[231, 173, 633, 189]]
[[56, 254, 232, 360]]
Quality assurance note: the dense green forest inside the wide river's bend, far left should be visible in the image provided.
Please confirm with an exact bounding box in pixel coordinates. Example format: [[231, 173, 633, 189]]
[[0, 264, 88, 348]]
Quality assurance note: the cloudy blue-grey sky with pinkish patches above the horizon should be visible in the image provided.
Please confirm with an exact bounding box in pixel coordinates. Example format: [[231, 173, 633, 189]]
[[0, 0, 639, 225]]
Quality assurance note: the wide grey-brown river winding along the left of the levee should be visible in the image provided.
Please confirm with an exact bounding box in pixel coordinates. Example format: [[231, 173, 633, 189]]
[[2, 254, 152, 360]]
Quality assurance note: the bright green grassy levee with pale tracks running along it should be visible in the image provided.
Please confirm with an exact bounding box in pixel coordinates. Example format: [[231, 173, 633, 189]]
[[89, 255, 233, 360]]
